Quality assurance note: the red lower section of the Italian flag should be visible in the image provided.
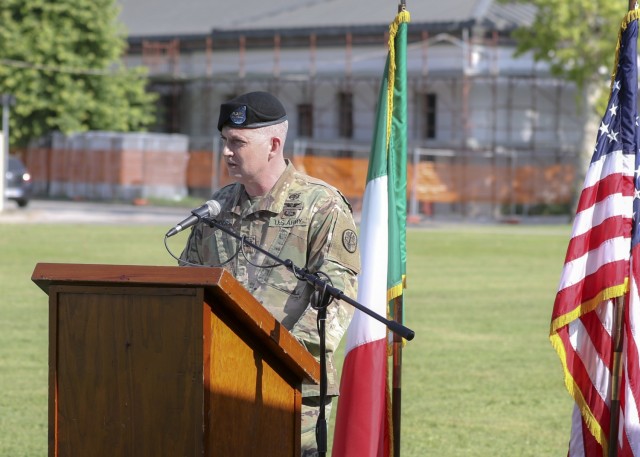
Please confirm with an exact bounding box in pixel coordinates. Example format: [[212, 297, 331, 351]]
[[333, 339, 391, 457]]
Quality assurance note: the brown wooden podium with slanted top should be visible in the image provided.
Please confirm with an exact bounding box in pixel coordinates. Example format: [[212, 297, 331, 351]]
[[31, 263, 320, 457]]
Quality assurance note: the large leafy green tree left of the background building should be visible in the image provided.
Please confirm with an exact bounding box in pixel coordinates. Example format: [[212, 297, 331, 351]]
[[0, 0, 155, 145]]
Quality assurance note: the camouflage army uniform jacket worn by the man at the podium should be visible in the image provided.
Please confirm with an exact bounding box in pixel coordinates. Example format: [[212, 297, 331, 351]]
[[181, 162, 360, 396]]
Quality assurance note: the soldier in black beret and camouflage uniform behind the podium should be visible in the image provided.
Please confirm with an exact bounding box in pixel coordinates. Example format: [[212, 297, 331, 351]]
[[181, 92, 360, 457]]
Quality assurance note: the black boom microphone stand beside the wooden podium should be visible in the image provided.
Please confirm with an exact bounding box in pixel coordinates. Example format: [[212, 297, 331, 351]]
[[200, 217, 415, 457]]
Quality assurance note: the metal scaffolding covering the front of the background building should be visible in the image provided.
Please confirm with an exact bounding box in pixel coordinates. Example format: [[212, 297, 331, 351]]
[[130, 27, 582, 217]]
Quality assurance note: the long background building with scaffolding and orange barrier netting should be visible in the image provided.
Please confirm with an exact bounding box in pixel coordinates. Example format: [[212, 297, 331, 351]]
[[114, 0, 581, 217]]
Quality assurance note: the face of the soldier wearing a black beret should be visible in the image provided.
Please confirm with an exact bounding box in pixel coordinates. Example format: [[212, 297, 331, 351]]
[[221, 127, 271, 185]]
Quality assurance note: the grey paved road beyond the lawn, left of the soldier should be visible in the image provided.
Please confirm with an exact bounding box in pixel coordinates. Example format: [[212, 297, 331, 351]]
[[0, 200, 191, 225]]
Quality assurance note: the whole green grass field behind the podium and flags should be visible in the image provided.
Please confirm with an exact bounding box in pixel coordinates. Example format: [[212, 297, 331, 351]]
[[0, 221, 572, 457]]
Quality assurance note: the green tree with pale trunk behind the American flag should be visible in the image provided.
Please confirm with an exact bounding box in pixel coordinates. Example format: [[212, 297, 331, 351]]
[[514, 0, 629, 196]]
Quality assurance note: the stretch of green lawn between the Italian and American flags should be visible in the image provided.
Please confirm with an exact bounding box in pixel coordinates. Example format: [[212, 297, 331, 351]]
[[402, 227, 572, 457]]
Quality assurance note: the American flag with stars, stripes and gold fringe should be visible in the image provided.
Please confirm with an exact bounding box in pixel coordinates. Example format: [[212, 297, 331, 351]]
[[550, 10, 640, 457]]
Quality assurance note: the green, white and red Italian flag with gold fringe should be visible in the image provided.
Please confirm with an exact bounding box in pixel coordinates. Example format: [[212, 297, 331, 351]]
[[332, 11, 410, 457]]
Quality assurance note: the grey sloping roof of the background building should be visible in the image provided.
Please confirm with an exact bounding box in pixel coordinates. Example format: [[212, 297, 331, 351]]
[[117, 0, 534, 37]]
